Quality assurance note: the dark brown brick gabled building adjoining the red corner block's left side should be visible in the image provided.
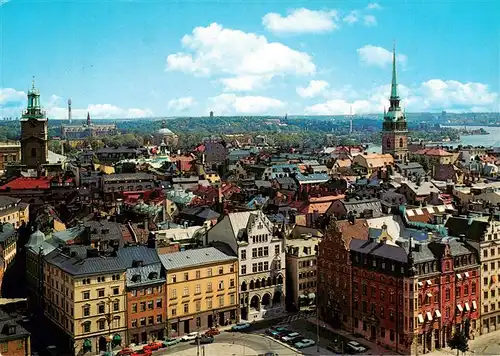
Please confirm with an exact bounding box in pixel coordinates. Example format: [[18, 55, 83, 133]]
[[317, 219, 368, 331]]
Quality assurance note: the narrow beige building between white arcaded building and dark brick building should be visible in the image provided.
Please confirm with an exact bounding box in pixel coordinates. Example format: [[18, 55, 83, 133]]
[[286, 226, 323, 310]]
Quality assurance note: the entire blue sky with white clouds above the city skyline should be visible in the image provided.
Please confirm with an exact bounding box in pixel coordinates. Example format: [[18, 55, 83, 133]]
[[0, 0, 500, 119]]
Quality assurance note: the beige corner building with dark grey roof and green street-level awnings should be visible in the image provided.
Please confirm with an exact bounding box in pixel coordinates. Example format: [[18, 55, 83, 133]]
[[43, 246, 127, 355]]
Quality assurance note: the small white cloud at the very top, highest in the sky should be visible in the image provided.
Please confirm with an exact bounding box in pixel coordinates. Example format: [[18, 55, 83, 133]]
[[262, 8, 339, 34]]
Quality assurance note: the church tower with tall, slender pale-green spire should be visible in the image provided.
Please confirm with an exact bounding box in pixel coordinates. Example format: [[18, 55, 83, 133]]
[[382, 47, 408, 161]]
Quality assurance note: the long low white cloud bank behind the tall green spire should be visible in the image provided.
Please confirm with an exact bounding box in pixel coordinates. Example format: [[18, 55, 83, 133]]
[[304, 79, 499, 115]]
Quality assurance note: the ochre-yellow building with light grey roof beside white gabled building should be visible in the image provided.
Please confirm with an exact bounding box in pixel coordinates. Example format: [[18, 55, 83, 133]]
[[160, 247, 239, 336]]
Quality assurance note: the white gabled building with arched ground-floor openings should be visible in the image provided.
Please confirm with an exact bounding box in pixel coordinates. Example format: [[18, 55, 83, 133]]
[[207, 211, 286, 321]]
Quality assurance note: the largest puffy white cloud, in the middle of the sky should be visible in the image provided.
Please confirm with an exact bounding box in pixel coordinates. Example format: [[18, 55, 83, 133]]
[[166, 23, 316, 90]]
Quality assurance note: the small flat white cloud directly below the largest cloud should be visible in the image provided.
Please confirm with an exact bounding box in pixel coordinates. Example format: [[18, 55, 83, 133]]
[[208, 94, 286, 115]]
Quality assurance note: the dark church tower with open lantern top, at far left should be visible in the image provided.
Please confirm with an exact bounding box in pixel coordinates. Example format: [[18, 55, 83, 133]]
[[21, 80, 49, 169]]
